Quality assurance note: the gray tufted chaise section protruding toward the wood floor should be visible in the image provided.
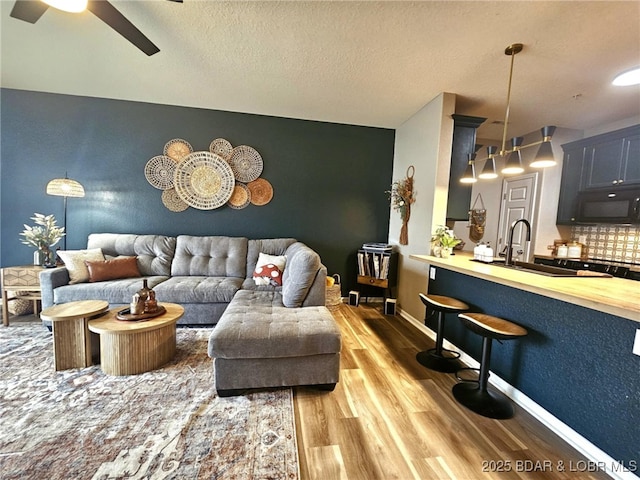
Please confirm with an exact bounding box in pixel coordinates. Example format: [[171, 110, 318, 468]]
[[209, 290, 341, 397]]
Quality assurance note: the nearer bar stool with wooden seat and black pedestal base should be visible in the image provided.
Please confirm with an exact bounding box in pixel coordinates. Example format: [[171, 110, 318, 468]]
[[453, 313, 527, 419]]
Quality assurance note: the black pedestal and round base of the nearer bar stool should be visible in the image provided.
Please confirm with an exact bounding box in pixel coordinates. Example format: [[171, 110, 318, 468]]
[[452, 337, 513, 419]]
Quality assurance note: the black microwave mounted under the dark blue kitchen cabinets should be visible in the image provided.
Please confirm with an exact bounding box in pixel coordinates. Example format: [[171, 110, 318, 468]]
[[576, 186, 640, 224]]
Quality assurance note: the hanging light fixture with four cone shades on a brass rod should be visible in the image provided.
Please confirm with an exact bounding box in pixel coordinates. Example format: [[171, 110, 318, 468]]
[[460, 43, 556, 183]]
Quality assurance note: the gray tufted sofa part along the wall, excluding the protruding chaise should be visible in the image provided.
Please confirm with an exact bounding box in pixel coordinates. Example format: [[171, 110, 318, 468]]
[[40, 233, 327, 326]]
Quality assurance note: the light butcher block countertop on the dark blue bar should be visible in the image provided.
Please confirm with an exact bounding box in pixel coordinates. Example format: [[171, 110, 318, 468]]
[[409, 252, 640, 322]]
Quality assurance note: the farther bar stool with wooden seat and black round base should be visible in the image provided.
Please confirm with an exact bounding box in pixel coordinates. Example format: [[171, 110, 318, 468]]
[[416, 293, 469, 373]]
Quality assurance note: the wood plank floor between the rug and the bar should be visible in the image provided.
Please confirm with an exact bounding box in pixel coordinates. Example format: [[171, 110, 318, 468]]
[[294, 304, 609, 480]]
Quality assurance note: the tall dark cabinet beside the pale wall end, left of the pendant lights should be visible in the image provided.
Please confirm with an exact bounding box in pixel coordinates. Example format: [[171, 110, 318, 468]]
[[447, 114, 486, 220]]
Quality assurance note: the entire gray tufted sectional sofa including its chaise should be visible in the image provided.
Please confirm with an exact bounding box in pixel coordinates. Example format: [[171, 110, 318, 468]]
[[40, 233, 341, 396]]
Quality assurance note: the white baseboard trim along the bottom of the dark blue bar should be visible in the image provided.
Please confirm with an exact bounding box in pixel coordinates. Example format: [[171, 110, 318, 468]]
[[397, 308, 640, 480]]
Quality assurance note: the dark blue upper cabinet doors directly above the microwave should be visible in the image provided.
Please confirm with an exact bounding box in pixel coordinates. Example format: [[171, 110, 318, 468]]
[[581, 125, 640, 189]]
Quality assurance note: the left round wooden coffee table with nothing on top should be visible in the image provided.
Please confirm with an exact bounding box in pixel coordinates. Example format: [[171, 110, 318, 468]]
[[40, 300, 109, 370]]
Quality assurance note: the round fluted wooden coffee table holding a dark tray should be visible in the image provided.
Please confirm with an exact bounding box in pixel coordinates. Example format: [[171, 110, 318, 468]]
[[89, 303, 184, 375]]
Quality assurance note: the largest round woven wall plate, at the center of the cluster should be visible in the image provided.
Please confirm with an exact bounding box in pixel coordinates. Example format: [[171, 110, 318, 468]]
[[173, 152, 236, 210]]
